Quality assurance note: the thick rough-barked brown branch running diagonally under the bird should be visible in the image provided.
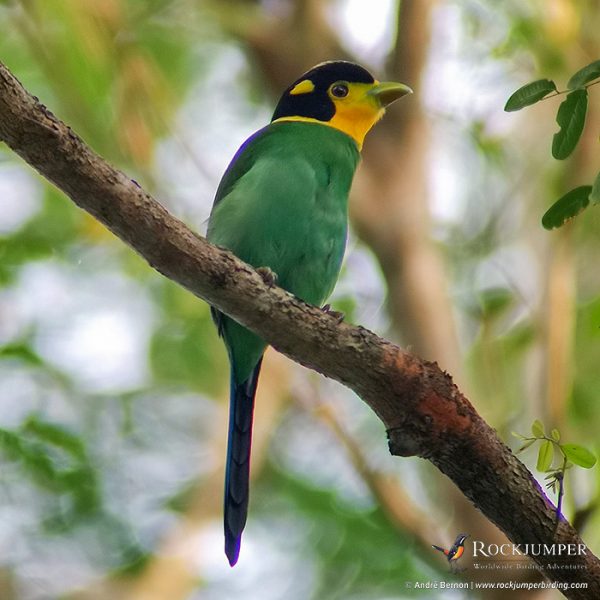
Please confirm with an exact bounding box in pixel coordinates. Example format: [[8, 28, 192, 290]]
[[0, 63, 600, 598]]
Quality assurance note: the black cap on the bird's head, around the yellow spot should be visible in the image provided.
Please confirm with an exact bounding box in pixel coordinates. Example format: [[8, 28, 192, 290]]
[[272, 60, 375, 121]]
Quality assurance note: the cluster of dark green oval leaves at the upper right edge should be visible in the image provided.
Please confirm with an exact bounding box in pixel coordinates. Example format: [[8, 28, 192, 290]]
[[504, 60, 600, 229]]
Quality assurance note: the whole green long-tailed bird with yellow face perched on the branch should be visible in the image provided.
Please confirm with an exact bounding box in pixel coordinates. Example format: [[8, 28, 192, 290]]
[[207, 60, 412, 567]]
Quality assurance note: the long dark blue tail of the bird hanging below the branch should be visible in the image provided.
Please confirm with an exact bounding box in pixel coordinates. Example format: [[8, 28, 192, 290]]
[[224, 359, 262, 567]]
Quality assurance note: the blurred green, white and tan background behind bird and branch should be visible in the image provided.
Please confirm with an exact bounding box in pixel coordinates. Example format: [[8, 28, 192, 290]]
[[0, 0, 600, 600]]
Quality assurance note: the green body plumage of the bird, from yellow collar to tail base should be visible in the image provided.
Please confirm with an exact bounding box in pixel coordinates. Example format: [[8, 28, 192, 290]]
[[208, 122, 359, 382]]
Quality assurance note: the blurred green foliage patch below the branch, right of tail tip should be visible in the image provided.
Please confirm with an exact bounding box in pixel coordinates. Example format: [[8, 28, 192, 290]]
[[255, 468, 437, 600]]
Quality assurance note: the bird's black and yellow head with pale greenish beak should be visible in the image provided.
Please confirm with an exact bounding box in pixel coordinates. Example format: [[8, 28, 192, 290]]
[[272, 61, 412, 148]]
